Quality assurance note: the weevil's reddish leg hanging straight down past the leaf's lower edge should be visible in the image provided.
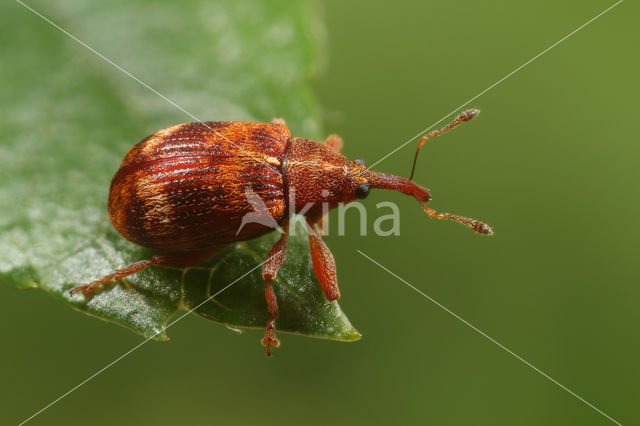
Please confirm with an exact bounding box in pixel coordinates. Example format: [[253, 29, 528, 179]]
[[262, 224, 289, 356]]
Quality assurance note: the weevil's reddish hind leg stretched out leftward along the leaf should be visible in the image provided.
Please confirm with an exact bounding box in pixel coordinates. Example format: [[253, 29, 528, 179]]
[[69, 246, 224, 299]]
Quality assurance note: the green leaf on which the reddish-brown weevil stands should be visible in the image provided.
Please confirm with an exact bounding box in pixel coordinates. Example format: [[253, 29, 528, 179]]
[[0, 0, 360, 341]]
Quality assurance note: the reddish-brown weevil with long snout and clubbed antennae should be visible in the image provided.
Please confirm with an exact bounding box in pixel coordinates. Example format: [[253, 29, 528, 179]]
[[71, 110, 492, 355]]
